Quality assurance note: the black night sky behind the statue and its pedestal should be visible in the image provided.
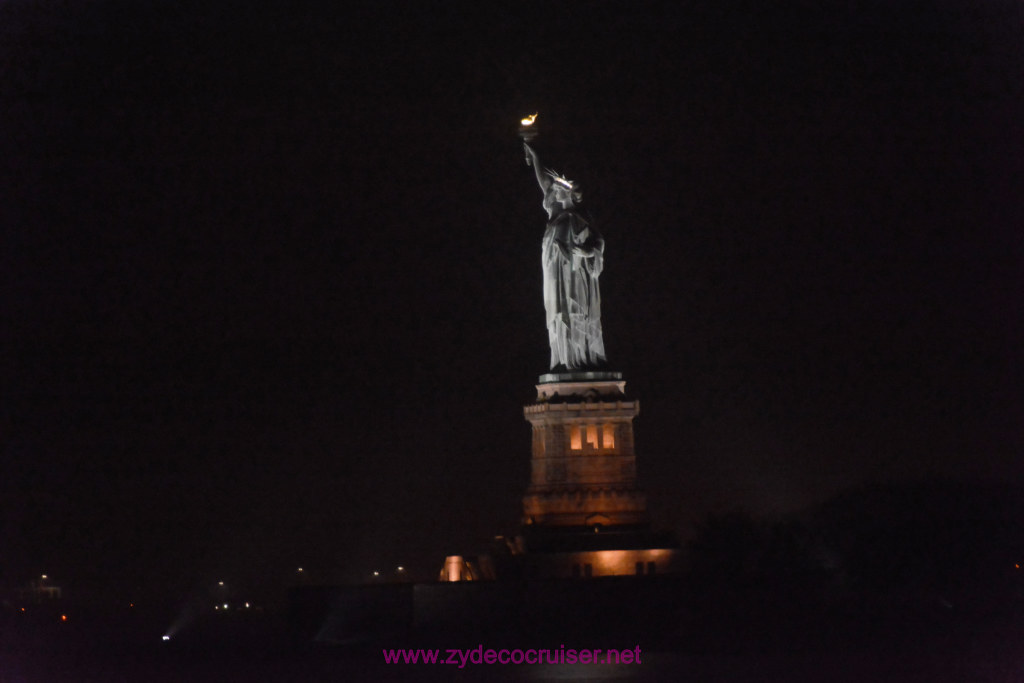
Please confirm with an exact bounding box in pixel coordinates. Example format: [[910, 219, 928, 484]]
[[0, 1, 1024, 595]]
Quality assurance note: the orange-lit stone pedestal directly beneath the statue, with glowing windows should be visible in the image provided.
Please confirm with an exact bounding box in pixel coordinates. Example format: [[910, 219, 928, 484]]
[[523, 372, 648, 527]]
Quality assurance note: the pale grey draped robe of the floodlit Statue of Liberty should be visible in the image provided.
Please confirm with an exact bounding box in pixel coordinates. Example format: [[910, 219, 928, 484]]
[[541, 211, 605, 370]]
